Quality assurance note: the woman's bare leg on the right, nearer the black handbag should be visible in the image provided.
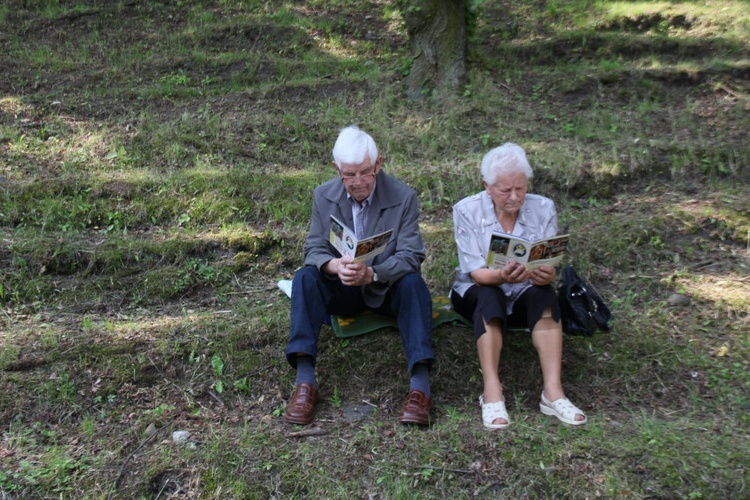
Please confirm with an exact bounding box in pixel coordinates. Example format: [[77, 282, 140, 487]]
[[531, 308, 585, 420]]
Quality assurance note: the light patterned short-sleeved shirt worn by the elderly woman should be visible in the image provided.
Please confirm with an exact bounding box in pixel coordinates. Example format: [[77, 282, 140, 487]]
[[451, 191, 557, 314]]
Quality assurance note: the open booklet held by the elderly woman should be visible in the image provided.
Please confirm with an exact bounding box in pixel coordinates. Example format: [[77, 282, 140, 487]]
[[487, 233, 570, 269]]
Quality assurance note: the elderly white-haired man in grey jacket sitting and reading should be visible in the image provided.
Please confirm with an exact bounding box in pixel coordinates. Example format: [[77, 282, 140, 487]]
[[284, 126, 433, 425]]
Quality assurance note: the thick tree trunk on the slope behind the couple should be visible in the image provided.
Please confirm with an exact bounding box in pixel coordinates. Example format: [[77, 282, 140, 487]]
[[398, 0, 468, 98]]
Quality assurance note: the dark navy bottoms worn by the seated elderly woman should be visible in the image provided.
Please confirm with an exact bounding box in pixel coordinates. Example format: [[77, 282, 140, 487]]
[[451, 285, 560, 341]]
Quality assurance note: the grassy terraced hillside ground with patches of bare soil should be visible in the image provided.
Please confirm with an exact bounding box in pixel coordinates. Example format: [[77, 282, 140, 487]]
[[0, 0, 750, 498]]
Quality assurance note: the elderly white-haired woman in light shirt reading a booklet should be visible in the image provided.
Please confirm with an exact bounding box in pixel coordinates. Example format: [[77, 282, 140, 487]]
[[451, 143, 587, 429]]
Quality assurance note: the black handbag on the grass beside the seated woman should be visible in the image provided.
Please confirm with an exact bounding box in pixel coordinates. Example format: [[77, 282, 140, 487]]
[[557, 265, 612, 336]]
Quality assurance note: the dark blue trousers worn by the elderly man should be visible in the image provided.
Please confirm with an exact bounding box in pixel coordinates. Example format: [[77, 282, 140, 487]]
[[286, 266, 434, 374]]
